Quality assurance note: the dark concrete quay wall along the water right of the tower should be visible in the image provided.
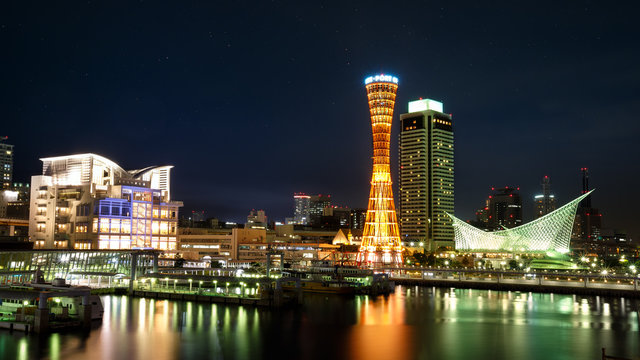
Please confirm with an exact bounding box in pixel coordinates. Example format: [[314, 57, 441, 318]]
[[392, 278, 640, 298]]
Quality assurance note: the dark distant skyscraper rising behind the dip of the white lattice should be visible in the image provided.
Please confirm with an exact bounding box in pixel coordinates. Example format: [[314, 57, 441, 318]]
[[487, 186, 522, 230]]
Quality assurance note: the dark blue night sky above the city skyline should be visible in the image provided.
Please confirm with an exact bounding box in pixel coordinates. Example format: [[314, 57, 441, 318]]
[[0, 1, 640, 238]]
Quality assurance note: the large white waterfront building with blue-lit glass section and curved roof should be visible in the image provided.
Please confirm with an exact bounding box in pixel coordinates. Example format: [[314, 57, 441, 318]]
[[29, 154, 182, 250]]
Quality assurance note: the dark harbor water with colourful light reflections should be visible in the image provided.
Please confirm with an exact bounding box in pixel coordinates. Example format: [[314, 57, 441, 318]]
[[0, 286, 640, 360]]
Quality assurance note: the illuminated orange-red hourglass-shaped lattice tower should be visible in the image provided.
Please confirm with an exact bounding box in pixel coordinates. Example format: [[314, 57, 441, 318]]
[[358, 75, 402, 266]]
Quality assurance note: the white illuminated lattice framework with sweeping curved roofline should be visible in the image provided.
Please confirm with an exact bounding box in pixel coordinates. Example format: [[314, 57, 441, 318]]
[[449, 190, 593, 253]]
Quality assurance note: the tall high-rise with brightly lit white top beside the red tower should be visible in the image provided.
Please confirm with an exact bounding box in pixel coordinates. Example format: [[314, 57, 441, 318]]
[[398, 99, 454, 250]]
